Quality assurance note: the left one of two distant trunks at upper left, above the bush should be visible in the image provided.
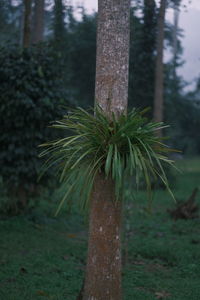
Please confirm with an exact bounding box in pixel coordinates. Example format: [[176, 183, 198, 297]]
[[22, 0, 32, 48]]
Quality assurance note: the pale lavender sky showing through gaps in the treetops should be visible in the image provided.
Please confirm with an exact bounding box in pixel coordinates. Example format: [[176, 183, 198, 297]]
[[73, 0, 200, 90]]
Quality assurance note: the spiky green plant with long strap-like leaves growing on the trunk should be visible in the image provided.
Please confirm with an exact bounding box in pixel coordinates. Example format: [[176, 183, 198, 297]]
[[41, 107, 173, 212]]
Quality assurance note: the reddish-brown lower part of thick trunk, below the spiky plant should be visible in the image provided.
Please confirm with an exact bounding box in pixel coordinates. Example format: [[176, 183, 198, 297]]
[[83, 174, 122, 300]]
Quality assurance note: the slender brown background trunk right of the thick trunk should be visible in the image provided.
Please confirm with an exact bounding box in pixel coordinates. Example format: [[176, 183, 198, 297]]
[[154, 0, 166, 136]]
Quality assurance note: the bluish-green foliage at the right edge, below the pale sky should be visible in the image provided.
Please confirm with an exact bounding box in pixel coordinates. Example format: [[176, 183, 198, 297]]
[[165, 64, 200, 155]]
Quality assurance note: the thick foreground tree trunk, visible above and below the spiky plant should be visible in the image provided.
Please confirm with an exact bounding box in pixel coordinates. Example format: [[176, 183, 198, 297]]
[[83, 0, 130, 300]]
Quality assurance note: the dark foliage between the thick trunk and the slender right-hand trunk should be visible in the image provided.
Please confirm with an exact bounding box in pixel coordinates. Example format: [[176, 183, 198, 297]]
[[129, 0, 157, 115]]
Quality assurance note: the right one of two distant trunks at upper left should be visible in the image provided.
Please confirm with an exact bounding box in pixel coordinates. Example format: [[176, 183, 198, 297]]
[[32, 0, 45, 44]]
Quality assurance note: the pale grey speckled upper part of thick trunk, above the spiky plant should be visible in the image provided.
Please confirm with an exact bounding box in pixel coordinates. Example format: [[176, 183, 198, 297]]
[[95, 0, 130, 119]]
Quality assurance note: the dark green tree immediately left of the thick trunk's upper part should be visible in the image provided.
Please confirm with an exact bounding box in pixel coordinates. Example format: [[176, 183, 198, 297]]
[[69, 10, 96, 107]]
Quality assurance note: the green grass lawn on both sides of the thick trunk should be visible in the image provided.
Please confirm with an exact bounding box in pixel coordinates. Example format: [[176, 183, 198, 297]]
[[0, 158, 200, 300]]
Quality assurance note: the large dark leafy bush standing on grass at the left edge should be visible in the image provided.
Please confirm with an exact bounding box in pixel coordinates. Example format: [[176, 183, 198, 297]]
[[0, 45, 69, 198]]
